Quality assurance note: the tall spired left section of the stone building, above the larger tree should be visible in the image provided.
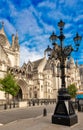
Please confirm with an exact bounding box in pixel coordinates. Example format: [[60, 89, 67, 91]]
[[0, 23, 20, 99]]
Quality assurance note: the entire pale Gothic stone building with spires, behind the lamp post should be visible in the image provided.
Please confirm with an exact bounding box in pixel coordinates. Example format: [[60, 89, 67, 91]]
[[0, 25, 81, 99]]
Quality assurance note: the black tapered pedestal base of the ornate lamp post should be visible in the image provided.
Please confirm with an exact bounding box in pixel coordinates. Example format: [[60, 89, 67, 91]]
[[52, 89, 78, 126]]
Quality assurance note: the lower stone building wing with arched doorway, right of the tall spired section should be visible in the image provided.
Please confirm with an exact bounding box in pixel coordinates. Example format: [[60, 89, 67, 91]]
[[9, 57, 81, 99]]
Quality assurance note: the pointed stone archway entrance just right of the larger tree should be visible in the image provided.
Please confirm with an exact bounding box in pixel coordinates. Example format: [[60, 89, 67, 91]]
[[17, 79, 28, 100]]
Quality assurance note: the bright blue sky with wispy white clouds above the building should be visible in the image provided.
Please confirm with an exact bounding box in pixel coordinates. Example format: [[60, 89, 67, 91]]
[[0, 0, 83, 65]]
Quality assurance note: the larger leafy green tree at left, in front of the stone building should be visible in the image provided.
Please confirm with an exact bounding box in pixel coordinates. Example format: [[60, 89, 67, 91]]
[[0, 73, 19, 96]]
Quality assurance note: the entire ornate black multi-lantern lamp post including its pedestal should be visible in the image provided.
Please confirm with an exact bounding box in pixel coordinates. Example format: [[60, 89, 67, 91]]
[[46, 20, 82, 126]]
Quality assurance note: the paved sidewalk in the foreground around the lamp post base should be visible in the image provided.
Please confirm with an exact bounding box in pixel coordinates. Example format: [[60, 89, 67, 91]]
[[0, 112, 83, 130]]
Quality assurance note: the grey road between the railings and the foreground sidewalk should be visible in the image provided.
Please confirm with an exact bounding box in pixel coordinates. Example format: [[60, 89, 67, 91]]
[[0, 104, 55, 124]]
